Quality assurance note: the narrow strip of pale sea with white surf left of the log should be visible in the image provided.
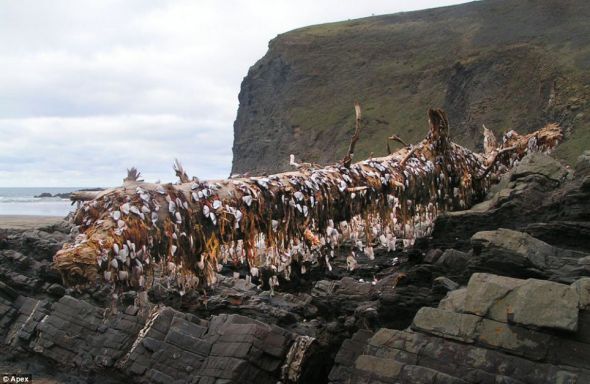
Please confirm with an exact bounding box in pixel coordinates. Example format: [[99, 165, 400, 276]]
[[0, 187, 81, 217]]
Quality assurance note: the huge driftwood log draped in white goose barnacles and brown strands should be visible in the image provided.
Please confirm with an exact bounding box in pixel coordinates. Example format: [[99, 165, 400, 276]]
[[54, 106, 562, 290]]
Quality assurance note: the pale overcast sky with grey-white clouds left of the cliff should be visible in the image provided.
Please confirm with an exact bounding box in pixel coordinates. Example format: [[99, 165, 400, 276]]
[[0, 0, 472, 187]]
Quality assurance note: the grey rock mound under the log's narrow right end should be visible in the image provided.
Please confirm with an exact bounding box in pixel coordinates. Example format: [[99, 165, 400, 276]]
[[431, 154, 590, 252]]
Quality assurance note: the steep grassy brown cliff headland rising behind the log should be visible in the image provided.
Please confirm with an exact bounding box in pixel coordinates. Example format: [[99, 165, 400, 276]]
[[232, 0, 590, 174]]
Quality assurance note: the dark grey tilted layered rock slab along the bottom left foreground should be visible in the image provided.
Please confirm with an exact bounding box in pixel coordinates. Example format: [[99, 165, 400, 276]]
[[0, 285, 316, 384]]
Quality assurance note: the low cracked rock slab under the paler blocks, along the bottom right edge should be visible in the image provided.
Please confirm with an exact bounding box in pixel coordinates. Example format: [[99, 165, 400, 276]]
[[330, 318, 590, 384]]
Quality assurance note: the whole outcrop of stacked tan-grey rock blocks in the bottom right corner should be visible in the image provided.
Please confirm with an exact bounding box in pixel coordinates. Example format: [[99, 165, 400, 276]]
[[330, 274, 590, 384]]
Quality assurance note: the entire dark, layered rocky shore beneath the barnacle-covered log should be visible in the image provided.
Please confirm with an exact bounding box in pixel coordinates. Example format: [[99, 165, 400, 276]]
[[0, 152, 590, 384]]
